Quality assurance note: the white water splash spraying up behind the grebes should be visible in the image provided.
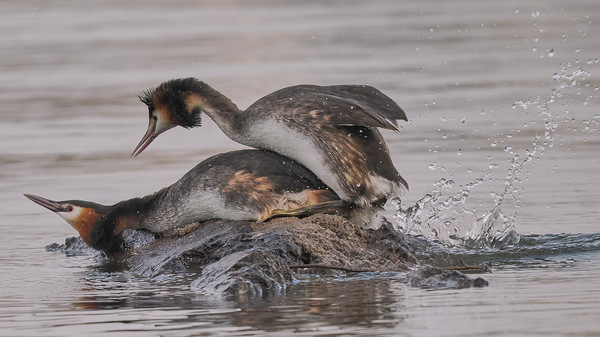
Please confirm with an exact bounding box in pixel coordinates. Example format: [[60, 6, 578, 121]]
[[393, 62, 592, 249]]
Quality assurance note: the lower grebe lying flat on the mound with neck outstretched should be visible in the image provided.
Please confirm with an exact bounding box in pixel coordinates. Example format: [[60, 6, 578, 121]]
[[25, 150, 347, 253]]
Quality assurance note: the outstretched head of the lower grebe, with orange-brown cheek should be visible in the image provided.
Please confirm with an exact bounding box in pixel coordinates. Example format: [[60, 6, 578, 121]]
[[24, 194, 120, 252]]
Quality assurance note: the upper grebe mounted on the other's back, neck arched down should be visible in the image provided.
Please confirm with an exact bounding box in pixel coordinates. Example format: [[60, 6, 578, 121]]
[[132, 78, 408, 206]]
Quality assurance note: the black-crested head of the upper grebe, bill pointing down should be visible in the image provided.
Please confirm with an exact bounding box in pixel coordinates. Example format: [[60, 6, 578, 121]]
[[132, 77, 202, 157]]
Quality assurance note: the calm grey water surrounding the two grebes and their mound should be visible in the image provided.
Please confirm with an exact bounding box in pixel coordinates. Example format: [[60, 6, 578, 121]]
[[0, 0, 600, 336]]
